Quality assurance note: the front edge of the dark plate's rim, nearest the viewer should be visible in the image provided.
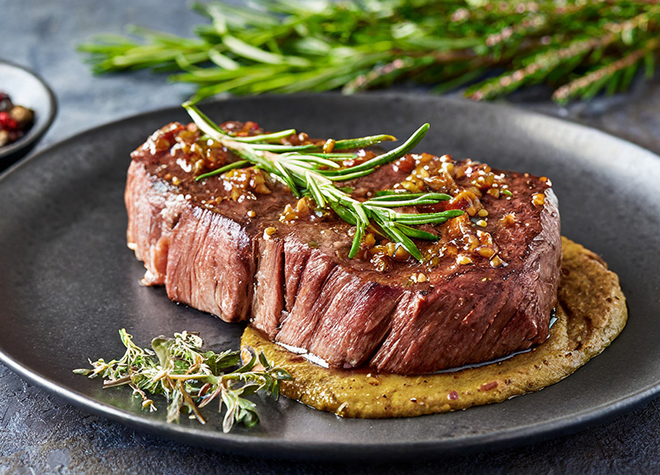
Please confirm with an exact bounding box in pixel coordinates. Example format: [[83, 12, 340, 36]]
[[5, 348, 660, 461]]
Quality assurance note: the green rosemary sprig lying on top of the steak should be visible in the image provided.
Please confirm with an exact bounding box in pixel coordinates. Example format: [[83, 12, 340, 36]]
[[183, 103, 463, 261]]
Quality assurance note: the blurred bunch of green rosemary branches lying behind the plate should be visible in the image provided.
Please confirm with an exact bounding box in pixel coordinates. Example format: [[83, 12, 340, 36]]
[[79, 0, 660, 102]]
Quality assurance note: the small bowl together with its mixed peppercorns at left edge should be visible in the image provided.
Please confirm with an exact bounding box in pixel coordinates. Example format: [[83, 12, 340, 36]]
[[0, 59, 57, 170]]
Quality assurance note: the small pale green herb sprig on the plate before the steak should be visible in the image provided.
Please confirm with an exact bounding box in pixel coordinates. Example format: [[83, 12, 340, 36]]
[[73, 329, 291, 432]]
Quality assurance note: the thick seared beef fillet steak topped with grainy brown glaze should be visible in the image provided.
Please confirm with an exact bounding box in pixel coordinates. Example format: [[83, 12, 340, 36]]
[[125, 123, 561, 374]]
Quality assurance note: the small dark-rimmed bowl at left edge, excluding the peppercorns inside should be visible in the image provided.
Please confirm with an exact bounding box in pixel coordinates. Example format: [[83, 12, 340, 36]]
[[0, 59, 57, 170]]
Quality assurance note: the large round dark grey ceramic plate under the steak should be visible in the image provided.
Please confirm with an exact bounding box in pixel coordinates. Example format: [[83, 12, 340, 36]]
[[0, 95, 660, 460]]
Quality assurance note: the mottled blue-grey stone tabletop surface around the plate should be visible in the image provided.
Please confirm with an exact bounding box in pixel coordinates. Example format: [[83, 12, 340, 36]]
[[0, 0, 660, 474]]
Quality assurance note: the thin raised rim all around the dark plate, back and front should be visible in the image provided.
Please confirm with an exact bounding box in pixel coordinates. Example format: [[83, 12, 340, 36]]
[[0, 92, 660, 460]]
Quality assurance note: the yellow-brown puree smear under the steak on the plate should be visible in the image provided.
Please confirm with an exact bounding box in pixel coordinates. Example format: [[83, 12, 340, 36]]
[[241, 238, 628, 418]]
